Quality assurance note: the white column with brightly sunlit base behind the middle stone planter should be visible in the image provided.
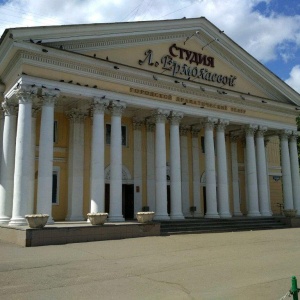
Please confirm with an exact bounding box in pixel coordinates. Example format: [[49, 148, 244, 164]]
[[90, 98, 108, 213]]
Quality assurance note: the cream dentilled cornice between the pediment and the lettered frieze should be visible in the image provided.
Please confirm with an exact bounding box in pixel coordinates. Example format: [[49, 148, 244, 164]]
[[3, 50, 297, 117]]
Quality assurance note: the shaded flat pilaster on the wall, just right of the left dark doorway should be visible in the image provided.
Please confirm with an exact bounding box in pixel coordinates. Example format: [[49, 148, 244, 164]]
[[133, 120, 143, 217]]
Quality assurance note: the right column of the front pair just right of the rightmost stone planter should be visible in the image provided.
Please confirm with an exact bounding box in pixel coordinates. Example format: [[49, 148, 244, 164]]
[[169, 111, 184, 220]]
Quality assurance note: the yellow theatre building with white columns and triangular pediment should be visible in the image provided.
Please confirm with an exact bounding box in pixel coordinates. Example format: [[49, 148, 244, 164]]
[[0, 17, 300, 225]]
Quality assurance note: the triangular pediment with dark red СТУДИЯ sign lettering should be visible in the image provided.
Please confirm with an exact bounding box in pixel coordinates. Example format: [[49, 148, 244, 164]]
[[2, 18, 300, 105]]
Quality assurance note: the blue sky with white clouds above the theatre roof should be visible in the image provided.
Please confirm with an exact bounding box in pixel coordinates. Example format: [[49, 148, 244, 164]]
[[0, 0, 300, 92]]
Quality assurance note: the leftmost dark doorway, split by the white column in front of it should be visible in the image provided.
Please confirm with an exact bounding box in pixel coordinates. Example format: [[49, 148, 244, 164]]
[[105, 184, 134, 219]]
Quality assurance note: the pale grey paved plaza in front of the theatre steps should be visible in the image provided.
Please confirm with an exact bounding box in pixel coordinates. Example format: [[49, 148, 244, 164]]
[[0, 228, 300, 300]]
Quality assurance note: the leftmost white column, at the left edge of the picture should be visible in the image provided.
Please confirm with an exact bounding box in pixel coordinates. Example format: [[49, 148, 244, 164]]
[[0, 101, 17, 224]]
